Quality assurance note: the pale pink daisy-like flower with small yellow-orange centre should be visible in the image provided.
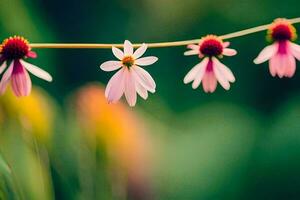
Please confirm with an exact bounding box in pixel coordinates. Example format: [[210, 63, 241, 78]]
[[100, 40, 158, 106]]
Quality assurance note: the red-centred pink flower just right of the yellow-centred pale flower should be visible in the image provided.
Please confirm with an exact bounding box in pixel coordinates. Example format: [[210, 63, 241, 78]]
[[183, 35, 237, 93]]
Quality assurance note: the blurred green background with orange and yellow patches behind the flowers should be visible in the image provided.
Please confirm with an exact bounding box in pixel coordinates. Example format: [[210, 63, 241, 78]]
[[0, 0, 300, 200]]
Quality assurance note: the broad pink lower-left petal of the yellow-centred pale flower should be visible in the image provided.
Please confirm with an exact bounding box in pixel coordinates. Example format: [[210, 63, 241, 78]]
[[105, 68, 127, 103]]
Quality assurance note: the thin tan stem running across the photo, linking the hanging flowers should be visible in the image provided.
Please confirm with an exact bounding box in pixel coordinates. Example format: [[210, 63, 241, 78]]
[[19, 17, 300, 49]]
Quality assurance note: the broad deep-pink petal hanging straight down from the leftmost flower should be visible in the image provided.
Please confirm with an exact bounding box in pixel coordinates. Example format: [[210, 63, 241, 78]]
[[11, 60, 31, 97]]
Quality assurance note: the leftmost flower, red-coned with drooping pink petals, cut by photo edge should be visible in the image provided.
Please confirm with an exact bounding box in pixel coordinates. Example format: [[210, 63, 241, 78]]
[[0, 36, 52, 97]]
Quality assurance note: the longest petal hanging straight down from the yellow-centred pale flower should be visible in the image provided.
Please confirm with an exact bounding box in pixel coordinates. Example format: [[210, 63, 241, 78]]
[[125, 70, 137, 107]]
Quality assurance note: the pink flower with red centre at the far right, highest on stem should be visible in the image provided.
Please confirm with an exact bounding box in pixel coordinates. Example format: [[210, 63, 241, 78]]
[[254, 19, 300, 78]]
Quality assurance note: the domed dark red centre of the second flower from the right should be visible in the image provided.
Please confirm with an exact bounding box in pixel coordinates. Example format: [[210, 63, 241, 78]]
[[200, 38, 223, 57]]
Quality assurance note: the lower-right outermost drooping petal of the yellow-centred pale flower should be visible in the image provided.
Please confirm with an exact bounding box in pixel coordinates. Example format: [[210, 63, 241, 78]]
[[130, 66, 156, 93]]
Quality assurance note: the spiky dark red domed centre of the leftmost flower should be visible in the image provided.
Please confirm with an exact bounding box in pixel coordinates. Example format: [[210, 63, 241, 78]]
[[0, 36, 30, 60]]
